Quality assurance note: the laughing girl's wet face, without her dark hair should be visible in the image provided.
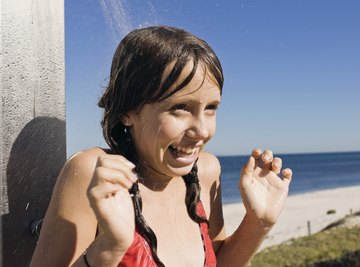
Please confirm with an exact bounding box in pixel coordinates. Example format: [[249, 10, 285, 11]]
[[125, 63, 221, 180]]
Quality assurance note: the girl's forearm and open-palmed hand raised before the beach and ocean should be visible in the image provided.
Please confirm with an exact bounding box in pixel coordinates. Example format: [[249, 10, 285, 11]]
[[217, 149, 292, 267]]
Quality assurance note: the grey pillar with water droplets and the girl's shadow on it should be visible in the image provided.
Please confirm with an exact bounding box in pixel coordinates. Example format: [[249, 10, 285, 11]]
[[0, 0, 66, 267]]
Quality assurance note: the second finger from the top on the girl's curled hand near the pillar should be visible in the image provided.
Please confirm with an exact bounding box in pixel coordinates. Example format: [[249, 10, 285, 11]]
[[94, 167, 137, 189]]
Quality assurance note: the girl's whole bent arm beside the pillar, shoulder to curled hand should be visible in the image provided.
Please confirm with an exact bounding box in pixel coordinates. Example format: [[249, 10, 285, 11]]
[[30, 149, 138, 267]]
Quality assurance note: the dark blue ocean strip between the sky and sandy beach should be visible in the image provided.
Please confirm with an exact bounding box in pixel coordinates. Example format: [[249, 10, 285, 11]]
[[218, 152, 360, 204]]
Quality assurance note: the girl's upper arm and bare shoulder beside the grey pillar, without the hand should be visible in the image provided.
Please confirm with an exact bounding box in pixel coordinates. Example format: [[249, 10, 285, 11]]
[[30, 152, 97, 266]]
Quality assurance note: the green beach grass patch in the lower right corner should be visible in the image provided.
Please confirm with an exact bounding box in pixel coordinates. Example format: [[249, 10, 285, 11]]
[[250, 219, 360, 267]]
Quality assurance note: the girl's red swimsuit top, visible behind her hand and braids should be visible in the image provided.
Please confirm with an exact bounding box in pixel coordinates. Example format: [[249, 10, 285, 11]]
[[118, 201, 216, 267]]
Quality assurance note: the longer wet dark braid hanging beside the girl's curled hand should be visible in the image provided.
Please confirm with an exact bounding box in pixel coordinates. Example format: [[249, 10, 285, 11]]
[[129, 183, 165, 267]]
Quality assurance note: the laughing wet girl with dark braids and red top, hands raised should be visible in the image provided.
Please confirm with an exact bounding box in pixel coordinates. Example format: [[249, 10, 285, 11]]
[[31, 26, 292, 267]]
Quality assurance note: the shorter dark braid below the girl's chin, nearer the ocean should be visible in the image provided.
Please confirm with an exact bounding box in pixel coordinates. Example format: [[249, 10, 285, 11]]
[[183, 162, 209, 224]]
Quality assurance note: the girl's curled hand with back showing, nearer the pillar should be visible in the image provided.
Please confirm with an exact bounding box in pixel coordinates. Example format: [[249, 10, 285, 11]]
[[87, 155, 137, 251]]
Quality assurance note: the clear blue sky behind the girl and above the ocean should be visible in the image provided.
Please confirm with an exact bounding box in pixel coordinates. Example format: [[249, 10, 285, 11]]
[[65, 0, 360, 155]]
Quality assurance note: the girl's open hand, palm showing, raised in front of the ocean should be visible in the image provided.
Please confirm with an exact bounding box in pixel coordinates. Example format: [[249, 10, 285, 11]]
[[240, 149, 292, 226]]
